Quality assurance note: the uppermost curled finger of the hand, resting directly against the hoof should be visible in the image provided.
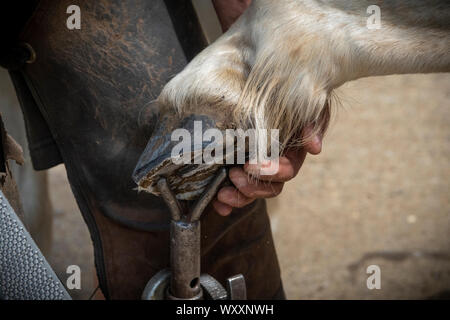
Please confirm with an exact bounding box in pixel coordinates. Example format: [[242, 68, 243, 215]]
[[244, 148, 306, 182]]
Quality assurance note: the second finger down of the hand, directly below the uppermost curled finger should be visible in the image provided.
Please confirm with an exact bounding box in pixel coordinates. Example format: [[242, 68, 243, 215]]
[[229, 167, 283, 198]]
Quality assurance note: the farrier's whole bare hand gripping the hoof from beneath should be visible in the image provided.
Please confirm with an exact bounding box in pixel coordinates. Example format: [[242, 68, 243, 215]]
[[213, 127, 322, 216]]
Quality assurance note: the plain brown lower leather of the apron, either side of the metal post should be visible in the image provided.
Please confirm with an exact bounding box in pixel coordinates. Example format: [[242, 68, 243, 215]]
[[89, 200, 284, 299]]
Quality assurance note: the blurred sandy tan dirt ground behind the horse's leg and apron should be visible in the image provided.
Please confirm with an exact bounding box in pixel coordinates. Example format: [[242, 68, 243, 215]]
[[44, 74, 450, 299]]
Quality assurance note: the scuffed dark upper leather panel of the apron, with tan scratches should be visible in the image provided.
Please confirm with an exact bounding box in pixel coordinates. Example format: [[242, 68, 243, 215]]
[[21, 0, 186, 230]]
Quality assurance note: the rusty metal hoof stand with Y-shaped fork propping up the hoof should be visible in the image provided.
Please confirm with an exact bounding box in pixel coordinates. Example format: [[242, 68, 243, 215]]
[[142, 168, 247, 300]]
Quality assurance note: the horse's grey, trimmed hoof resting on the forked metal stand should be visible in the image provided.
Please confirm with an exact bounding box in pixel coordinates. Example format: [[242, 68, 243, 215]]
[[133, 114, 230, 200]]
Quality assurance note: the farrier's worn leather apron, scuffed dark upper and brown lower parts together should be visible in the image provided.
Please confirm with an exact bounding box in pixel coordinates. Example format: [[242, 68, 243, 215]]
[[16, 0, 280, 299]]
